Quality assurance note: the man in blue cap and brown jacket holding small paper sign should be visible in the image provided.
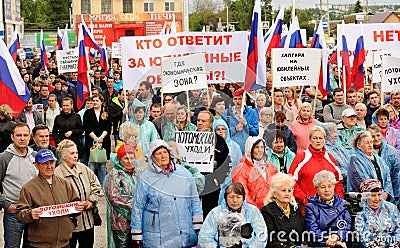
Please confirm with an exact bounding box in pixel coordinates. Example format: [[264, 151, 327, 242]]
[[16, 149, 84, 248]]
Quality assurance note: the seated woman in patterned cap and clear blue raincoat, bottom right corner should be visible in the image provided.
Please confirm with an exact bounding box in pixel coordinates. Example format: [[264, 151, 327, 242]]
[[355, 179, 400, 247]]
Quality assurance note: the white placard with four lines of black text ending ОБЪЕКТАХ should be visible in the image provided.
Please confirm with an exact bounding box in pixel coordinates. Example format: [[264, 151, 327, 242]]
[[271, 48, 322, 87]]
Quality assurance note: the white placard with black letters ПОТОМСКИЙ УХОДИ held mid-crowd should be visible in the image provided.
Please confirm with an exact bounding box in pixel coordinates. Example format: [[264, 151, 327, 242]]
[[175, 131, 215, 173]]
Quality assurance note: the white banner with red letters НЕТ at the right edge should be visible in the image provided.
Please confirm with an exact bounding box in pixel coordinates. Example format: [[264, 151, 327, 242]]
[[337, 23, 400, 66]]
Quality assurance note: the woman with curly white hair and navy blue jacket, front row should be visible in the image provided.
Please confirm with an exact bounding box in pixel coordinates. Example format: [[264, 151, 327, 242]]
[[305, 170, 351, 247]]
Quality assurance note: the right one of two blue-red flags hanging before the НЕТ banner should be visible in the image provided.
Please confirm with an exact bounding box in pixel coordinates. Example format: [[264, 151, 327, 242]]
[[351, 35, 365, 91]]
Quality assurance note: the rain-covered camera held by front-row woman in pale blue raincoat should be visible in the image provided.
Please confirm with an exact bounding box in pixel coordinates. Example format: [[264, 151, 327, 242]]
[[218, 211, 253, 248]]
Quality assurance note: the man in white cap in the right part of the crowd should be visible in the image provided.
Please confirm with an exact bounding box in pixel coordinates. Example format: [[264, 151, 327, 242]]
[[337, 108, 365, 150]]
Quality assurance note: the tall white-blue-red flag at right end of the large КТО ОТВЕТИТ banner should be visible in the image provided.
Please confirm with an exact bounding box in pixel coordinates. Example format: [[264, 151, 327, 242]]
[[244, 0, 266, 92]]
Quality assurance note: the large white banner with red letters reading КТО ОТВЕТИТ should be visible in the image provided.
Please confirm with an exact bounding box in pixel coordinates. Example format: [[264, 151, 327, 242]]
[[121, 32, 248, 89]]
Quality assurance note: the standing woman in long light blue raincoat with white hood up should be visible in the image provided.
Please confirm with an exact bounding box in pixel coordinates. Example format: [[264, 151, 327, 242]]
[[131, 140, 203, 247]]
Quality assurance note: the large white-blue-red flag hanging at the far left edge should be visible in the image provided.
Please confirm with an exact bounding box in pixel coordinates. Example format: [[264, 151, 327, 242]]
[[0, 39, 31, 117]]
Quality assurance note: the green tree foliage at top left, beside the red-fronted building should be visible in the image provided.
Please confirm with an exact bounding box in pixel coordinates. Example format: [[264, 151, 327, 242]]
[[21, 0, 71, 29]]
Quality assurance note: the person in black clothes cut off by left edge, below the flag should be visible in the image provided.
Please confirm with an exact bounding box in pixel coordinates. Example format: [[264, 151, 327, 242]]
[[0, 104, 15, 152]]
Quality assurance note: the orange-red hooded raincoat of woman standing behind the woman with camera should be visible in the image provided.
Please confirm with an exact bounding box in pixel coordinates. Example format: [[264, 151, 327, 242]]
[[232, 156, 278, 210]]
